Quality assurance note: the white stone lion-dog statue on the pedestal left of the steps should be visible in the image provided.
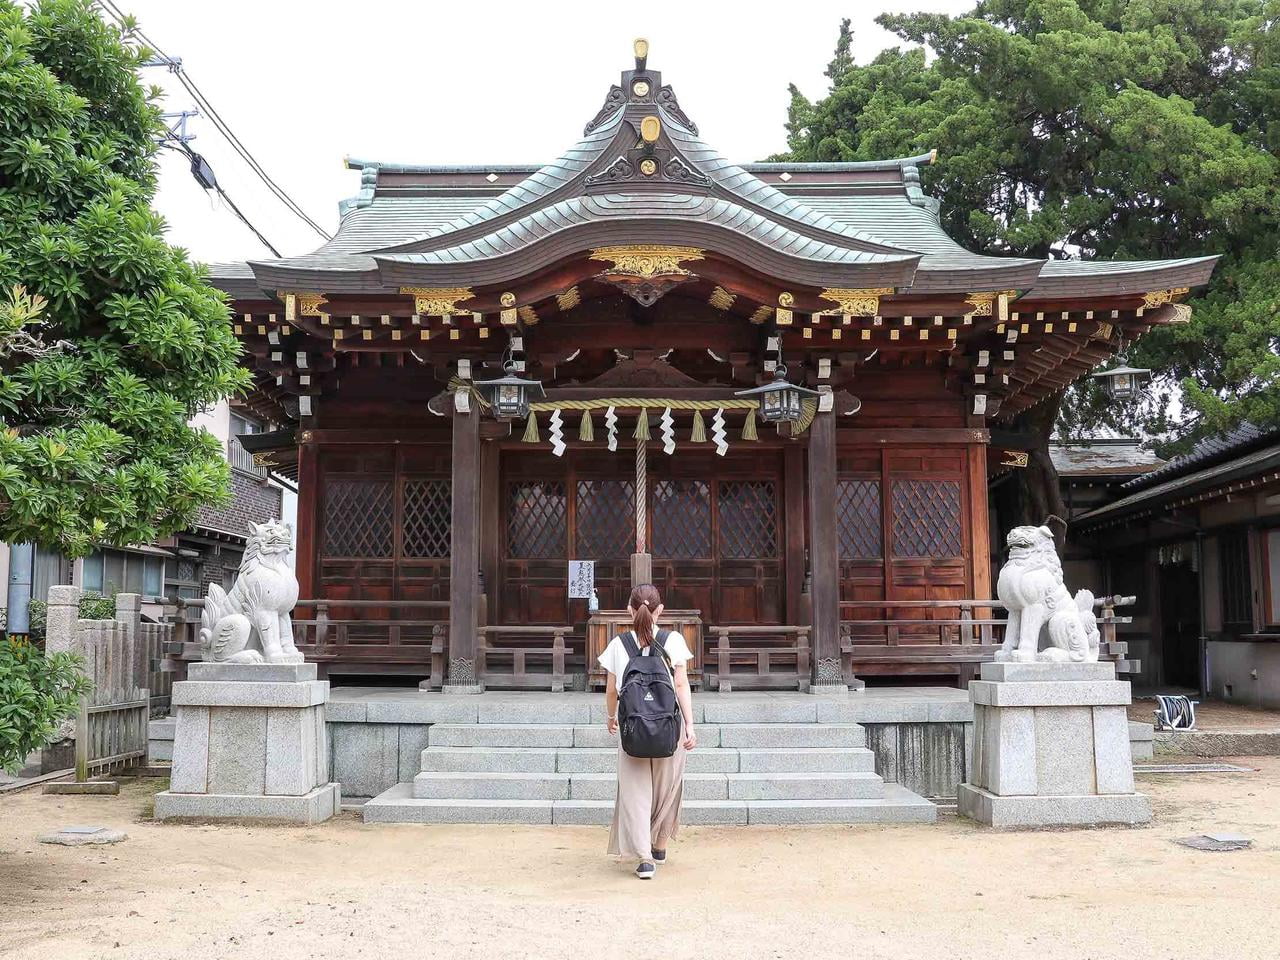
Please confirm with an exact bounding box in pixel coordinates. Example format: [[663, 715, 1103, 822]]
[[200, 520, 303, 663]]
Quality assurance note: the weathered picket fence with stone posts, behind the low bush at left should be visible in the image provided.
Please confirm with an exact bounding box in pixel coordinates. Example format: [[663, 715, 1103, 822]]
[[45, 586, 153, 781]]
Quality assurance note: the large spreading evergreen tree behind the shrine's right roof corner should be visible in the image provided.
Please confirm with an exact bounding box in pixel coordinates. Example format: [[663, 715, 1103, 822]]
[[778, 0, 1280, 527]]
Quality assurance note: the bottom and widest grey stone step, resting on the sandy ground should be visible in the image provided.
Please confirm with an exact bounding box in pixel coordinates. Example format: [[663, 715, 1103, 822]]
[[362, 783, 937, 826]]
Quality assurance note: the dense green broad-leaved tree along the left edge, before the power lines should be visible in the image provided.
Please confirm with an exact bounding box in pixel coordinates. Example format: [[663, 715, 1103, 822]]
[[0, 0, 248, 556]]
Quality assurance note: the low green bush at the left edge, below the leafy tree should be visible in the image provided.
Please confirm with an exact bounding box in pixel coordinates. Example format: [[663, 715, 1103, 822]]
[[0, 637, 90, 773]]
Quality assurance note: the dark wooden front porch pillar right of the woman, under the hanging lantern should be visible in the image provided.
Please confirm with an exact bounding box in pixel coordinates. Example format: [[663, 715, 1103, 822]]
[[809, 413, 849, 694]]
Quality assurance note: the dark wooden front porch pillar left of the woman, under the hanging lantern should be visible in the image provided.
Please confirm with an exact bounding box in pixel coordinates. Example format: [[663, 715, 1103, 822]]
[[444, 404, 483, 694]]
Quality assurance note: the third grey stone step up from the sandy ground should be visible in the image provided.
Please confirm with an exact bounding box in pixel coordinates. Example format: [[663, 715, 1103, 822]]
[[421, 746, 876, 773]]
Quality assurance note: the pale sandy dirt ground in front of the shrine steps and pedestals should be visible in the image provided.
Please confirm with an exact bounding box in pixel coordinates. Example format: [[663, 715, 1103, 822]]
[[0, 758, 1280, 960]]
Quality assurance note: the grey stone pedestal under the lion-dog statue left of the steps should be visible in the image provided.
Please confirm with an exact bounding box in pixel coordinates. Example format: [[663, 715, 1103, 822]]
[[156, 663, 339, 823]]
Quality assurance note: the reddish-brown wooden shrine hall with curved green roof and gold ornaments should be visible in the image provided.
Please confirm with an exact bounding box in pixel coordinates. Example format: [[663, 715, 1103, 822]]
[[212, 42, 1213, 691]]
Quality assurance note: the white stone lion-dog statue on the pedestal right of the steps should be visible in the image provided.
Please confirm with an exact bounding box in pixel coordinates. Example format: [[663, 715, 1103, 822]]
[[996, 526, 1098, 663]]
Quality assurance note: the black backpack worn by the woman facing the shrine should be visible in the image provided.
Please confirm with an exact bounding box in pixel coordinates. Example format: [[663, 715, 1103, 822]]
[[618, 630, 682, 758]]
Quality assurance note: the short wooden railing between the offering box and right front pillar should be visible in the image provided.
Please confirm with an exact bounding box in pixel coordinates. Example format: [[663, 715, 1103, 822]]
[[707, 625, 812, 692]]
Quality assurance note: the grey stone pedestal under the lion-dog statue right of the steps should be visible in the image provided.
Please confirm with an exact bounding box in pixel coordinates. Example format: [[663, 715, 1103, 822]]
[[957, 663, 1151, 827]]
